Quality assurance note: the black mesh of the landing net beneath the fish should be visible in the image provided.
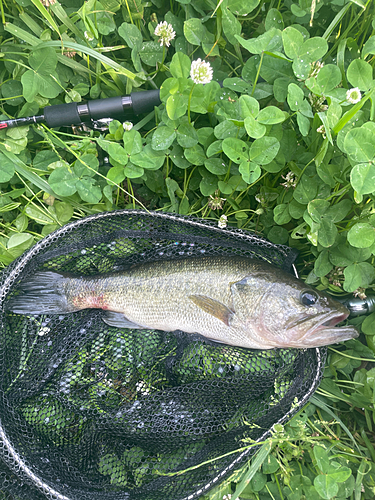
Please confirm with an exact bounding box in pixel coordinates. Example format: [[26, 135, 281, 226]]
[[0, 210, 325, 500]]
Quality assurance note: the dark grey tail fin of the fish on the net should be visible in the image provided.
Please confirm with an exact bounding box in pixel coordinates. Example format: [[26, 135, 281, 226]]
[[6, 271, 78, 315]]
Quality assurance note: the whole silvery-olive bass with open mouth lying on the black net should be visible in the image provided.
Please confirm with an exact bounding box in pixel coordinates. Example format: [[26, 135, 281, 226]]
[[7, 256, 358, 349]]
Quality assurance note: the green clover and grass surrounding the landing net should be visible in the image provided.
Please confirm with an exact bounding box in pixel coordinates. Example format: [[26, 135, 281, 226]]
[[0, 0, 375, 500]]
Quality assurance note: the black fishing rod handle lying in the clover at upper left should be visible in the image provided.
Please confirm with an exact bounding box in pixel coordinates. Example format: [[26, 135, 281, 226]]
[[0, 89, 161, 130]]
